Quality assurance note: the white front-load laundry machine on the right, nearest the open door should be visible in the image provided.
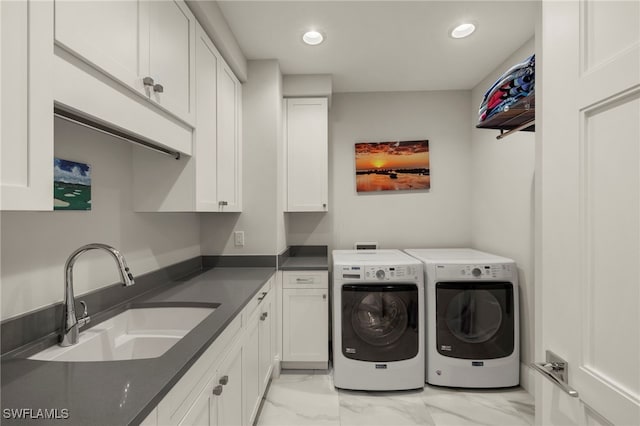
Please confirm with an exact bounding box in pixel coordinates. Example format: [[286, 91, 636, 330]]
[[405, 249, 520, 388]]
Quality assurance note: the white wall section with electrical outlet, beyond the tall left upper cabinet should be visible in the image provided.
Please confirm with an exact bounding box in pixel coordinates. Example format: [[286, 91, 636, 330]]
[[201, 60, 286, 255]]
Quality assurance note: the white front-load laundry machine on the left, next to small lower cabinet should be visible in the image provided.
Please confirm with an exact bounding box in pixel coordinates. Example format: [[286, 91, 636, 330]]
[[333, 250, 425, 391]]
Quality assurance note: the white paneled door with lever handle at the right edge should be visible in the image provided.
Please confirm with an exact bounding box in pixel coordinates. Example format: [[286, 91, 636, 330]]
[[536, 0, 640, 425]]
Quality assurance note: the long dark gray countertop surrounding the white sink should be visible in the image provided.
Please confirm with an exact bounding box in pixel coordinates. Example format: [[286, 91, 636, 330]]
[[1, 268, 274, 425]]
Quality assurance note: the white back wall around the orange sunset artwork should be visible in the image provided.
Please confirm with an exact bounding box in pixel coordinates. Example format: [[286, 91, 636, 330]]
[[287, 91, 471, 249]]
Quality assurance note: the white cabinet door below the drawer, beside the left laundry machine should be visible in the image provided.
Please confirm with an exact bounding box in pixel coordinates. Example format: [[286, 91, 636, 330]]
[[282, 288, 329, 362]]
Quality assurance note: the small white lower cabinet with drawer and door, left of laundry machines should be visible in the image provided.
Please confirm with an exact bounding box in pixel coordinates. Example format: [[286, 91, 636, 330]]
[[282, 271, 329, 368]]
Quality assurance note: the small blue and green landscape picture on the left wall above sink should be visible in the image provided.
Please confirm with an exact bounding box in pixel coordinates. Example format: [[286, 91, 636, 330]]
[[53, 158, 91, 210]]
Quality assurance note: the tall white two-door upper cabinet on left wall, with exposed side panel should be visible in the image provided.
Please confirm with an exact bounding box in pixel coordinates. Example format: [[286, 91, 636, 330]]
[[133, 25, 242, 212]]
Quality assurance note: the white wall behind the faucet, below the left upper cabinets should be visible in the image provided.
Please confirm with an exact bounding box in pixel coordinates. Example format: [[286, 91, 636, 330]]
[[1, 119, 200, 319]]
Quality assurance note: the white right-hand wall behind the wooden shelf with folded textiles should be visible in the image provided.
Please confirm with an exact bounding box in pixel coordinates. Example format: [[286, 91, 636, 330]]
[[471, 39, 535, 389]]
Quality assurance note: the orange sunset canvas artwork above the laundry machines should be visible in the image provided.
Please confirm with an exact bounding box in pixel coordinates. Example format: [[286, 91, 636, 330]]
[[355, 140, 431, 192]]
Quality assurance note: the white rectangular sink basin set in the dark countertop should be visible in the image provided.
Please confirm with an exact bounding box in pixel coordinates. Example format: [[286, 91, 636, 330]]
[[29, 307, 215, 362]]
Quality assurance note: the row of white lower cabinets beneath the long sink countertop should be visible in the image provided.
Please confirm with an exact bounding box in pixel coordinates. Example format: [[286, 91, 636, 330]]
[[158, 277, 274, 426]]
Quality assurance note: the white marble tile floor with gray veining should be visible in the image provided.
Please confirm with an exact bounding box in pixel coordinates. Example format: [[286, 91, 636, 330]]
[[255, 370, 534, 426]]
